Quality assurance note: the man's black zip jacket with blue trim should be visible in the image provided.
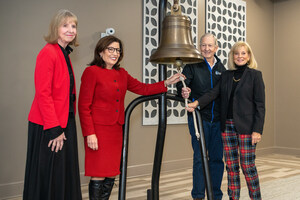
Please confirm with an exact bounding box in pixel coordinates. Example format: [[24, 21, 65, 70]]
[[176, 56, 226, 122]]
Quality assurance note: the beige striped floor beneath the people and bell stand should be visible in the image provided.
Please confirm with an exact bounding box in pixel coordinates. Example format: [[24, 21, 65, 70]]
[[10, 154, 300, 200]]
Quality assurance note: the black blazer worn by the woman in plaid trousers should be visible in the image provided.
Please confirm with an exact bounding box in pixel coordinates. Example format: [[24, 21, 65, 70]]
[[198, 67, 265, 134]]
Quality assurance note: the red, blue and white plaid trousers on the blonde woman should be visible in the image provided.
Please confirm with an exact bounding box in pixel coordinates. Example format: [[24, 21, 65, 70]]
[[222, 119, 261, 200]]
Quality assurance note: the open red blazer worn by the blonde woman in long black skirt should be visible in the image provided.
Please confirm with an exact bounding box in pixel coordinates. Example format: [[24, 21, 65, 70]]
[[28, 44, 76, 130]]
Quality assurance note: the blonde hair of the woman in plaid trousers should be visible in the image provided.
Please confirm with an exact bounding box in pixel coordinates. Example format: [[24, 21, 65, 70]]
[[228, 41, 257, 70]]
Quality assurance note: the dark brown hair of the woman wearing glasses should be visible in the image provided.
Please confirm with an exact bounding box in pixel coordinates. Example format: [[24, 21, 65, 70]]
[[88, 35, 124, 70]]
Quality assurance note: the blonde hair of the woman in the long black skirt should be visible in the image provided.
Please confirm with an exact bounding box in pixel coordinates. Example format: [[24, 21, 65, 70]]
[[44, 9, 79, 46]]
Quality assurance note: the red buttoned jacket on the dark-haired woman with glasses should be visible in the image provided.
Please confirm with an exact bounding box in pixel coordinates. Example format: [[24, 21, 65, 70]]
[[78, 65, 167, 136]]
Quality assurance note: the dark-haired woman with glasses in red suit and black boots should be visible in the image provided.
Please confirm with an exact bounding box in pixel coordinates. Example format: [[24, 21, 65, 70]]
[[78, 36, 180, 200]]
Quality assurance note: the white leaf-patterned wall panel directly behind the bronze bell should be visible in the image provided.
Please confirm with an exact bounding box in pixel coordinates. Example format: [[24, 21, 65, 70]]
[[143, 0, 198, 125]]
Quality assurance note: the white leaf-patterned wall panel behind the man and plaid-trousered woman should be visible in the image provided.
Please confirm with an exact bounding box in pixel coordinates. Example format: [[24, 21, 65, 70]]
[[205, 0, 246, 67]]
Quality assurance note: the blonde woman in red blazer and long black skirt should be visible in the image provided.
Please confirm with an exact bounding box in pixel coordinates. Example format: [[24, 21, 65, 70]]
[[23, 10, 82, 200]]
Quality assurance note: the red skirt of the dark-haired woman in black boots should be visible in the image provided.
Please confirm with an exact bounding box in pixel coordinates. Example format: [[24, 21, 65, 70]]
[[84, 123, 123, 177]]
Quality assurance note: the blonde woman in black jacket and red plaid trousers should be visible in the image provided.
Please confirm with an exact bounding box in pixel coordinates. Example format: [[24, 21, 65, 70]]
[[183, 42, 265, 199]]
